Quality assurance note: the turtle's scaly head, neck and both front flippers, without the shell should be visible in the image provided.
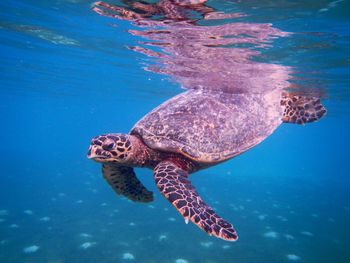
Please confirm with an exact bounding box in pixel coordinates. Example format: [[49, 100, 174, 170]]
[[88, 134, 238, 241]]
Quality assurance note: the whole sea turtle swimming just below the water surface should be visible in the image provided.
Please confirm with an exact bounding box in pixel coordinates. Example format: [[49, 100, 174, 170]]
[[88, 89, 326, 241]]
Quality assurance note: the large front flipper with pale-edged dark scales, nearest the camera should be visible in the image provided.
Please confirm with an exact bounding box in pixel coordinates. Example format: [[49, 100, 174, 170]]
[[154, 161, 238, 241]]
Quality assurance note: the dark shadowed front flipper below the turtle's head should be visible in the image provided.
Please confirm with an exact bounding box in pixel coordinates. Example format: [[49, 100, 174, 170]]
[[102, 163, 153, 203]]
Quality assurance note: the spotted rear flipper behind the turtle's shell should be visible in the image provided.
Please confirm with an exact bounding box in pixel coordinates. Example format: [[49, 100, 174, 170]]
[[281, 92, 327, 124]]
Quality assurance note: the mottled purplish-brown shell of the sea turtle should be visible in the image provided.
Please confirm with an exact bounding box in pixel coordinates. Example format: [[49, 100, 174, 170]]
[[130, 90, 283, 163]]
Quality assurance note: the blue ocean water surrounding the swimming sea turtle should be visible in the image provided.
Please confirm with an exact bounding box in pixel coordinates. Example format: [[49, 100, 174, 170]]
[[0, 0, 350, 263]]
